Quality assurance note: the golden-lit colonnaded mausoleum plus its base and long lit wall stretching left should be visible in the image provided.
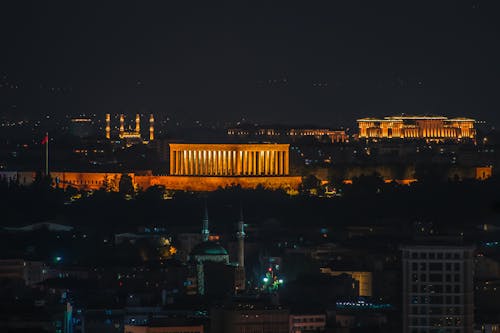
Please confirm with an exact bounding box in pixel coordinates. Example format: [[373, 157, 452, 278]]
[[23, 143, 302, 192]]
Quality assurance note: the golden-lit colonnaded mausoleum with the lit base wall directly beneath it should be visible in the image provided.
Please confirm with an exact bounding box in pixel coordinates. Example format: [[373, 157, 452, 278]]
[[163, 143, 302, 191]]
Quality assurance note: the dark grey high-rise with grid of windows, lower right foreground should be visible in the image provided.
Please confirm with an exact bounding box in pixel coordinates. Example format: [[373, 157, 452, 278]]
[[402, 239, 474, 333]]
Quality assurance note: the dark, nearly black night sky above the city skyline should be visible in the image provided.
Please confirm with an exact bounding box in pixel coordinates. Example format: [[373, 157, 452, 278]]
[[0, 0, 500, 126]]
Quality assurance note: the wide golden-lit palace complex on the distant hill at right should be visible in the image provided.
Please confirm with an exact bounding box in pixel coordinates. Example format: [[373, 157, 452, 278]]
[[357, 116, 476, 141]]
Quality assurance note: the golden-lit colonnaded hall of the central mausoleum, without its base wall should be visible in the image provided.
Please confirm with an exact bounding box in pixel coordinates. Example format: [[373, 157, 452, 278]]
[[170, 144, 290, 176]]
